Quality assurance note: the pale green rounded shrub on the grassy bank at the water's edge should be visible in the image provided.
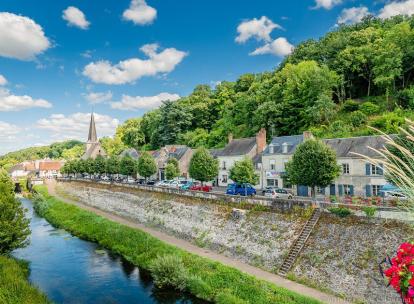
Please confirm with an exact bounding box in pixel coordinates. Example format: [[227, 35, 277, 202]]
[[150, 254, 188, 291]]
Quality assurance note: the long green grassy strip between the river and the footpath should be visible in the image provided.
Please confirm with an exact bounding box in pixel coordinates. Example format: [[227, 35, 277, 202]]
[[35, 186, 320, 304]]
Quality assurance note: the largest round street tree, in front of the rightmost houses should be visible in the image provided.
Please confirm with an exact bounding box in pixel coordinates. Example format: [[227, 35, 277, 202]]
[[286, 139, 340, 198]]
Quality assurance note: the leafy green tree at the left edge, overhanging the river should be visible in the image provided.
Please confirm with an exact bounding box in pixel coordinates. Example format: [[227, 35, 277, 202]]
[[0, 169, 30, 254]]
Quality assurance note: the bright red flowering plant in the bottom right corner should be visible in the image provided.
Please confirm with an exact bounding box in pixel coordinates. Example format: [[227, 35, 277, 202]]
[[383, 243, 414, 304]]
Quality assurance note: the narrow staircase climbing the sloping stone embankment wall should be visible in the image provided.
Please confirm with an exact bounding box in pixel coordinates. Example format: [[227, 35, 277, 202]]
[[279, 208, 322, 276]]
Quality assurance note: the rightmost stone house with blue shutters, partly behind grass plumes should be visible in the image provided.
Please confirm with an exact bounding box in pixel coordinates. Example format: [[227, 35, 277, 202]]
[[319, 136, 387, 196]]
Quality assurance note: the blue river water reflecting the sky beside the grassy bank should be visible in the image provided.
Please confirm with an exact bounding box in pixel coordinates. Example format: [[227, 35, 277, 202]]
[[14, 198, 205, 304]]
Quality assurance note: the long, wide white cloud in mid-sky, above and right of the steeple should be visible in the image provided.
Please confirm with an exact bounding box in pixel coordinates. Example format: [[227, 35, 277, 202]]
[[83, 44, 187, 84]]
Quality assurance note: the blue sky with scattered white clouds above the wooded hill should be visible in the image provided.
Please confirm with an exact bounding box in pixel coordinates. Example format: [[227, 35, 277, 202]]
[[0, 0, 414, 154]]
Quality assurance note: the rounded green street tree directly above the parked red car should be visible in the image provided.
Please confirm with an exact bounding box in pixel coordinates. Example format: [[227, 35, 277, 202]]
[[189, 148, 219, 183]]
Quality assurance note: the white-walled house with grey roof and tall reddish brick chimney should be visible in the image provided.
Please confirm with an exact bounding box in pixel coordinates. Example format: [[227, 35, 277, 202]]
[[212, 129, 266, 187]]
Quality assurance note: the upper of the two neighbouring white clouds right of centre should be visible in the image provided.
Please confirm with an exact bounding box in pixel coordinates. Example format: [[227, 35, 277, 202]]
[[236, 16, 282, 43]]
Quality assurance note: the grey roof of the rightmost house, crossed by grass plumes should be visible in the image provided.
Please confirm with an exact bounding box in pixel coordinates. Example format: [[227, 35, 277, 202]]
[[323, 136, 385, 158]]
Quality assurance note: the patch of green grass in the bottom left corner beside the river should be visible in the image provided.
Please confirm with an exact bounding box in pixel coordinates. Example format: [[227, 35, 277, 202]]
[[0, 255, 50, 304]]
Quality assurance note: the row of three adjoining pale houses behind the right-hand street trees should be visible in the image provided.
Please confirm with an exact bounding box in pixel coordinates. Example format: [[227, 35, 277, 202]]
[[214, 129, 386, 196]]
